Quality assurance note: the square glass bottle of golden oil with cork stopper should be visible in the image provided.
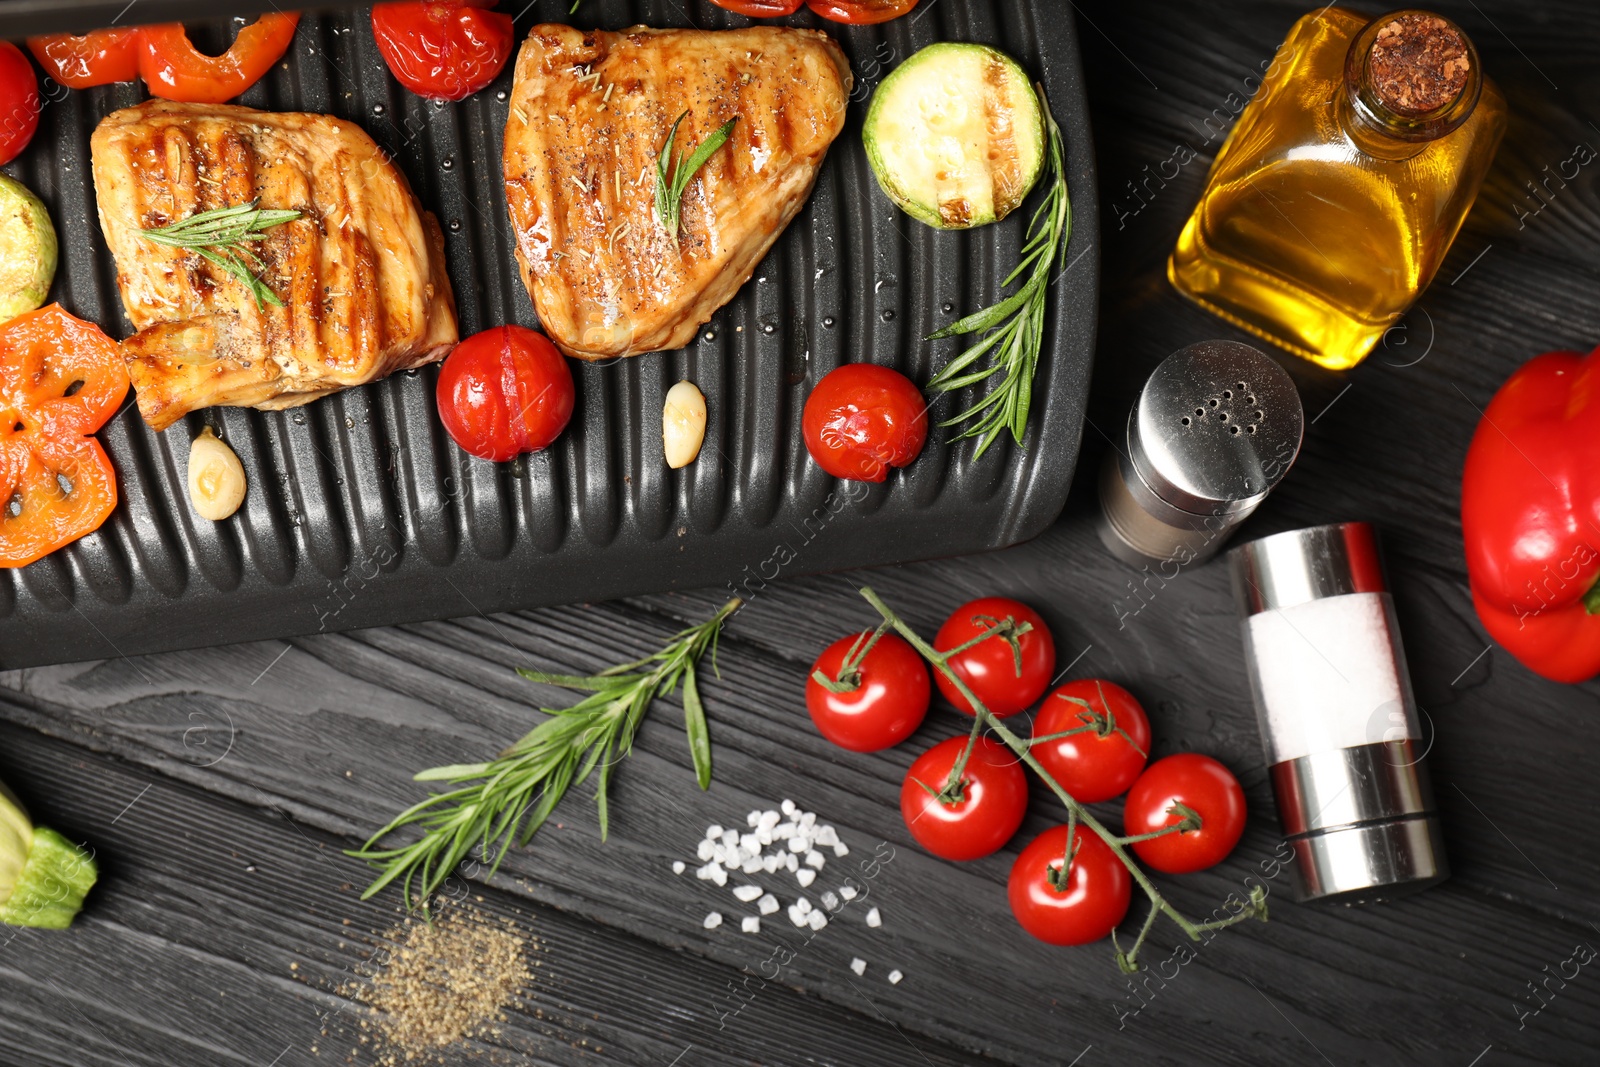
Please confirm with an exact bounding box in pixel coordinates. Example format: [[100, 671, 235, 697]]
[[1166, 6, 1506, 370]]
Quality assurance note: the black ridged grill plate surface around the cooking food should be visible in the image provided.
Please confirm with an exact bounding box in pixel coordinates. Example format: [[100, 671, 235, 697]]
[[0, 0, 1098, 669]]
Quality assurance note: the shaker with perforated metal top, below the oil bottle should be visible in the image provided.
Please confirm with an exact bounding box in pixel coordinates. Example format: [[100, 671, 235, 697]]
[[1099, 341, 1306, 577]]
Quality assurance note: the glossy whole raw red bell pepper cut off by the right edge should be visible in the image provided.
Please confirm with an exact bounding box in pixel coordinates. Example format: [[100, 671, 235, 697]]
[[1461, 349, 1600, 681]]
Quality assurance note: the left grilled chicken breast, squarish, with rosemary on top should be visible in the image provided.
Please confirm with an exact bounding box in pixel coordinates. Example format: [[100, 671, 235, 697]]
[[91, 101, 456, 429]]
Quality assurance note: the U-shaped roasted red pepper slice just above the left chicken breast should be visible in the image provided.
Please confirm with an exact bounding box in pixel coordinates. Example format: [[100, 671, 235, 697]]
[[139, 11, 299, 104]]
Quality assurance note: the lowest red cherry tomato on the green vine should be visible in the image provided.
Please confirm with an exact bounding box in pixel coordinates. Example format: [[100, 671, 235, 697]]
[[1006, 825, 1133, 945]]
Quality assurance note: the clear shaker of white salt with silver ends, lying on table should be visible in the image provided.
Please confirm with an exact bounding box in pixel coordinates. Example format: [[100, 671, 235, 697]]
[[1229, 523, 1450, 904]]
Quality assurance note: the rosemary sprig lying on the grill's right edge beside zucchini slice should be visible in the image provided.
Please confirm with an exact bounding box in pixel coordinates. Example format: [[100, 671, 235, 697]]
[[928, 86, 1072, 458]]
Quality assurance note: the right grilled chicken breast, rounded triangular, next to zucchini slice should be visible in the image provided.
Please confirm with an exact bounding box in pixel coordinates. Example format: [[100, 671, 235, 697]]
[[504, 26, 851, 360]]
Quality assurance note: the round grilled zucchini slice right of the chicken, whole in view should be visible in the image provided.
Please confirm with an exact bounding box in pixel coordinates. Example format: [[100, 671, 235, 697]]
[[862, 43, 1045, 230]]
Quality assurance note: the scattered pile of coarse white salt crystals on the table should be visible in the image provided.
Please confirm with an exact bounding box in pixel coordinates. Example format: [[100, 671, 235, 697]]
[[672, 800, 901, 984]]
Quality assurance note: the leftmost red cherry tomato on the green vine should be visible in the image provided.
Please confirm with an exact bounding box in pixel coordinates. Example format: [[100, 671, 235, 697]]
[[805, 630, 933, 752]]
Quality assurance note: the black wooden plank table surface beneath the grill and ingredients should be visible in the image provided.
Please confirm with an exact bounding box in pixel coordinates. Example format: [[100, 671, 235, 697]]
[[0, 0, 1600, 1067]]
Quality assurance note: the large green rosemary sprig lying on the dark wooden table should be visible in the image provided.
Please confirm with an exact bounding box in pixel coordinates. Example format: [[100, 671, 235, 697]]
[[347, 597, 741, 907]]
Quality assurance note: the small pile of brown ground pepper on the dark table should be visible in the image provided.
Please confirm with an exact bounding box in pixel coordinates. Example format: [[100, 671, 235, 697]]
[[339, 904, 533, 1067]]
